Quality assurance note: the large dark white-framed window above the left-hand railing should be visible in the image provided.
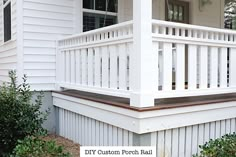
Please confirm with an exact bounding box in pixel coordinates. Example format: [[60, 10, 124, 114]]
[[83, 0, 118, 32]]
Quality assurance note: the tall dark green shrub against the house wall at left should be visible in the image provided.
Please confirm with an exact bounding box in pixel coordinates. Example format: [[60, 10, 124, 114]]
[[0, 71, 48, 156]]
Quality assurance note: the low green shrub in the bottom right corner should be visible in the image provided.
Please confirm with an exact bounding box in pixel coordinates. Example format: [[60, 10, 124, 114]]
[[193, 133, 236, 157]]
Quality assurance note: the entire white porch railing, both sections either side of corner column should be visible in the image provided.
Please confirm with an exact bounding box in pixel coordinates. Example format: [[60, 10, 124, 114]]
[[57, 20, 236, 104]]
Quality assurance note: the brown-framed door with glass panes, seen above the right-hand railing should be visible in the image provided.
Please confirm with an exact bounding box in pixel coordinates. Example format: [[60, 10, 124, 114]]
[[166, 0, 189, 23]]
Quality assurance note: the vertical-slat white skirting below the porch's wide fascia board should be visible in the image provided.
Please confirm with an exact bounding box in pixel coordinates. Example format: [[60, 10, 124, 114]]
[[56, 107, 236, 157]]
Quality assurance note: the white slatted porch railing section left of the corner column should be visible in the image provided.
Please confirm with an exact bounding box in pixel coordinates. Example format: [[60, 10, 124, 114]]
[[57, 21, 133, 97]]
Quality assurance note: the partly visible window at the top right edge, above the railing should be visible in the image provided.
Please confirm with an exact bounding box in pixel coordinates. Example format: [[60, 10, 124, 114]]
[[224, 0, 236, 30]]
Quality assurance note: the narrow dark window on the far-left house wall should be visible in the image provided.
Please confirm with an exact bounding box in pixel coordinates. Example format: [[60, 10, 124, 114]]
[[3, 0, 11, 42]]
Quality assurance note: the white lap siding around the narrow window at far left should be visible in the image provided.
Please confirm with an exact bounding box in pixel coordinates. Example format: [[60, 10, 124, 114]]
[[0, 0, 17, 84]]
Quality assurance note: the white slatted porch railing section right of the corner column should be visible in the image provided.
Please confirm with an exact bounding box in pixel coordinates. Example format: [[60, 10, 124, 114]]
[[153, 20, 236, 98]]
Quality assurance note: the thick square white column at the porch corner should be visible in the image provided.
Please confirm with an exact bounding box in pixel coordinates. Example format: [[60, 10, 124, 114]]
[[130, 0, 158, 107]]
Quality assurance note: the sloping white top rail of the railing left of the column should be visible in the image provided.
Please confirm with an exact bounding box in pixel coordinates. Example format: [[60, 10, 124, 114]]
[[58, 20, 133, 41]]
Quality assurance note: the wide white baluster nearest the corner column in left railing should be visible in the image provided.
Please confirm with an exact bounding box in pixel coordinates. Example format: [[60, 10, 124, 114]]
[[118, 44, 127, 90]]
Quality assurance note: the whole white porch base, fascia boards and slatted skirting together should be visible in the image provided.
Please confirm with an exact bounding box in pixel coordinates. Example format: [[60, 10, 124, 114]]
[[53, 93, 236, 157]]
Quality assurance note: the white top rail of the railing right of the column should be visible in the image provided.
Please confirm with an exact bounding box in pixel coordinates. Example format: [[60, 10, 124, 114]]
[[152, 20, 236, 35]]
